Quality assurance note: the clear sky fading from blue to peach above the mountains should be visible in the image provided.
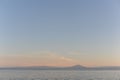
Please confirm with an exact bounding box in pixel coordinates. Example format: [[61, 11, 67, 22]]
[[0, 0, 120, 66]]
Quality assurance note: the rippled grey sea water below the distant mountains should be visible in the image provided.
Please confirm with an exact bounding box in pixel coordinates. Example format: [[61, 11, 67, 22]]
[[0, 70, 120, 80]]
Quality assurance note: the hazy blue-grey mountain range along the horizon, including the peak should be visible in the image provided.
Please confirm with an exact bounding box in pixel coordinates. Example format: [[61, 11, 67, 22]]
[[0, 65, 120, 70]]
